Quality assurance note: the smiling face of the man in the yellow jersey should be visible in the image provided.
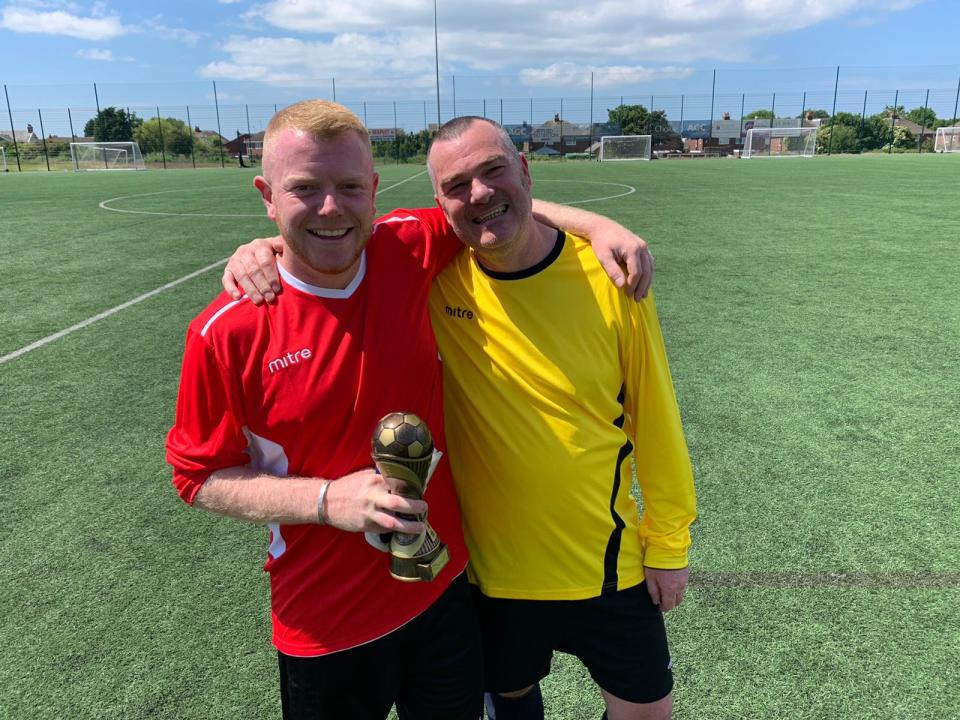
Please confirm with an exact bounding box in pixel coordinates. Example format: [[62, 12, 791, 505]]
[[428, 120, 534, 269]]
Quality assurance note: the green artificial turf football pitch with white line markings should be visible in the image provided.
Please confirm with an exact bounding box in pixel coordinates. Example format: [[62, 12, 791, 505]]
[[0, 155, 960, 720]]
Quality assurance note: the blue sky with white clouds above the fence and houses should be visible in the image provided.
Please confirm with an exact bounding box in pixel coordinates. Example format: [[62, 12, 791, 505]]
[[0, 0, 960, 131]]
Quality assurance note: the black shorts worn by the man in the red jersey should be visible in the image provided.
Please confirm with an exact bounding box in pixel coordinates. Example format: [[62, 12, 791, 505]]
[[280, 575, 483, 720]]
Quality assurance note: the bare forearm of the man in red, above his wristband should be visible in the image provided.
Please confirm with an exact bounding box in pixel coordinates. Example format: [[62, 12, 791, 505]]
[[194, 467, 323, 525]]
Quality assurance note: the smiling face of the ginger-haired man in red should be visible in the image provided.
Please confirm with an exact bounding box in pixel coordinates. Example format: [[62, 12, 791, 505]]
[[254, 128, 379, 288]]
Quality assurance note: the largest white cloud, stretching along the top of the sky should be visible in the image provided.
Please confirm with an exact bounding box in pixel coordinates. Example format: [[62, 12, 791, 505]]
[[200, 0, 923, 87]]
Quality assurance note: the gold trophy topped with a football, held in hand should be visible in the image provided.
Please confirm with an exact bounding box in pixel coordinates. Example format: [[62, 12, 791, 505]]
[[371, 412, 450, 582]]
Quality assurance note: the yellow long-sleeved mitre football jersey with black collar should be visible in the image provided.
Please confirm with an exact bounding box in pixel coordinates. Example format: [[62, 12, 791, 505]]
[[430, 233, 695, 600]]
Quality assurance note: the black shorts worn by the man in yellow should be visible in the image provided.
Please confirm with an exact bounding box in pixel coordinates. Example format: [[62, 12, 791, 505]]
[[474, 582, 673, 703]]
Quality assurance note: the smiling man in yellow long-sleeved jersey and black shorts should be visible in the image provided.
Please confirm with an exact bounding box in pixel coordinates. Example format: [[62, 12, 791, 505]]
[[428, 118, 695, 720]]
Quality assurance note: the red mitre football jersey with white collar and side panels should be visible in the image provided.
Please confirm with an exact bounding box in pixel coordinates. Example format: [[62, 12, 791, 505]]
[[167, 210, 467, 656]]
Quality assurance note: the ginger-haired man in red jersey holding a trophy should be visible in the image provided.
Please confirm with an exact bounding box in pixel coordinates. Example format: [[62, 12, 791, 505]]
[[167, 101, 656, 720]]
